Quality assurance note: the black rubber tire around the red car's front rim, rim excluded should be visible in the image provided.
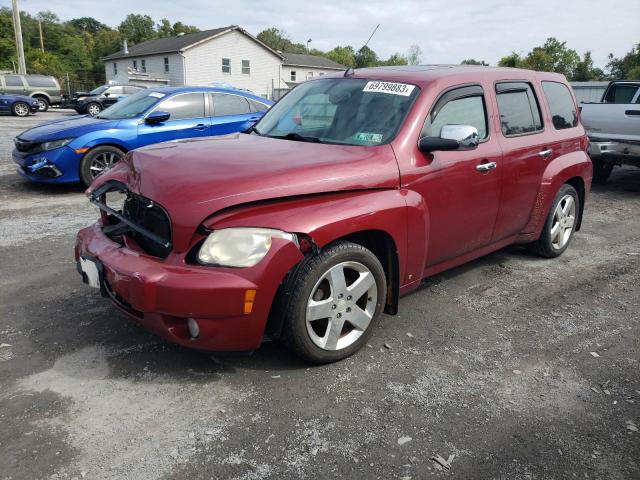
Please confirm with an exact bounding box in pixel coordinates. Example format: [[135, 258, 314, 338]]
[[281, 241, 387, 364]]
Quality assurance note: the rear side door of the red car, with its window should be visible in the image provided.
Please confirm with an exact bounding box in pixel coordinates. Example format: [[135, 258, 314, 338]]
[[493, 81, 557, 242]]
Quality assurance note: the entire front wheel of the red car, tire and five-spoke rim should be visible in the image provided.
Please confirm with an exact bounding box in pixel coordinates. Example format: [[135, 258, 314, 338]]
[[282, 241, 387, 364]]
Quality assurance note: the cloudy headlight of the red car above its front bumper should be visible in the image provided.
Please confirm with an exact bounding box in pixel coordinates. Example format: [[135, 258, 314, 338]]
[[198, 228, 298, 267]]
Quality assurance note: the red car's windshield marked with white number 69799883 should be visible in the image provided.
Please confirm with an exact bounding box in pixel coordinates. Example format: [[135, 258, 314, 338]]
[[254, 78, 420, 146]]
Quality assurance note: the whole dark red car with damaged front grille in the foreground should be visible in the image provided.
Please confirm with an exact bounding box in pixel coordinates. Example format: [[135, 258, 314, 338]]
[[75, 66, 592, 363]]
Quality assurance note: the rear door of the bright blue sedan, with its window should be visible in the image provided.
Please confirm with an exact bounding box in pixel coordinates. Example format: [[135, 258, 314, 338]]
[[210, 93, 262, 135]]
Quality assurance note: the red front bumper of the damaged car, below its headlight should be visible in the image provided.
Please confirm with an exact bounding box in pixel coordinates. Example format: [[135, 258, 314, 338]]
[[75, 222, 303, 351]]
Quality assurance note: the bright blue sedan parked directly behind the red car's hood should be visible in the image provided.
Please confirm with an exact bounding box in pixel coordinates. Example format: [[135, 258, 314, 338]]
[[13, 87, 273, 185]]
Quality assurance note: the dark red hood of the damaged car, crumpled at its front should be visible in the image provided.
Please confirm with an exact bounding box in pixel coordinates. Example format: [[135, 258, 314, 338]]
[[95, 133, 400, 251]]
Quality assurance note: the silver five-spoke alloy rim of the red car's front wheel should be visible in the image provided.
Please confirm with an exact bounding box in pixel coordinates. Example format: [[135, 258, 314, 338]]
[[306, 262, 378, 350]]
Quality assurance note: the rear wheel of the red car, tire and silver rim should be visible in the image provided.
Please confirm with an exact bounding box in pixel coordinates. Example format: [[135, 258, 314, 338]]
[[533, 183, 580, 258]]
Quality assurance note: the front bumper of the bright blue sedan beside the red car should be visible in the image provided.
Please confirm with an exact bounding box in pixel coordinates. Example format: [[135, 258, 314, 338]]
[[12, 147, 82, 183]]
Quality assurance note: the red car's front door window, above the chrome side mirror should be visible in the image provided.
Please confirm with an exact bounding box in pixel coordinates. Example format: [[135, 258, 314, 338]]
[[420, 86, 488, 139]]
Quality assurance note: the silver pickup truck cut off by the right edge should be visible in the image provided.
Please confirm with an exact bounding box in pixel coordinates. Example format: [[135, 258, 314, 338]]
[[580, 81, 640, 183]]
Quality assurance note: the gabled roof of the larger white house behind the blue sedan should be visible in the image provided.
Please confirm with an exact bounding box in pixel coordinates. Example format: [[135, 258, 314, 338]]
[[103, 25, 282, 60]]
